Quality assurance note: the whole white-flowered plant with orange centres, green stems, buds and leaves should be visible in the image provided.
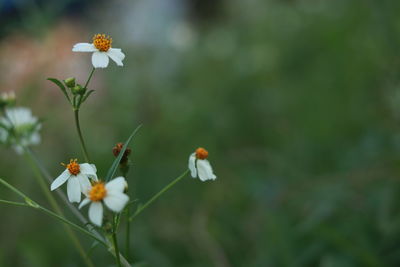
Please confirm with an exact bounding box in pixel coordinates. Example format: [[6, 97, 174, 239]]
[[0, 34, 216, 266]]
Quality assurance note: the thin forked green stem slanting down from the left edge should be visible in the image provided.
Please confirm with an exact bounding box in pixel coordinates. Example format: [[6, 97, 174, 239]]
[[0, 178, 107, 247]]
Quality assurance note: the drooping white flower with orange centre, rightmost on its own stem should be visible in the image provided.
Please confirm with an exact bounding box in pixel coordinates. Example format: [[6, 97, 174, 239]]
[[189, 147, 217, 182]]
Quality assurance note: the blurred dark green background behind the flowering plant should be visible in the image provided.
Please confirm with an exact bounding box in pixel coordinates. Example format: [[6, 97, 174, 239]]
[[0, 0, 400, 267]]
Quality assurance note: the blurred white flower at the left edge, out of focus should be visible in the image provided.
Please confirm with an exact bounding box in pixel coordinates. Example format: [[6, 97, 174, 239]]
[[0, 106, 41, 154]]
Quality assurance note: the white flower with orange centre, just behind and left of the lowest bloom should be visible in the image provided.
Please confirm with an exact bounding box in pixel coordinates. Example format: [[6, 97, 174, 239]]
[[50, 159, 97, 203]]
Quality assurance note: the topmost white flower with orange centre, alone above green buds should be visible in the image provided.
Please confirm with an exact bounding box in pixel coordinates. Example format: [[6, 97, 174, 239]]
[[72, 34, 125, 68]]
